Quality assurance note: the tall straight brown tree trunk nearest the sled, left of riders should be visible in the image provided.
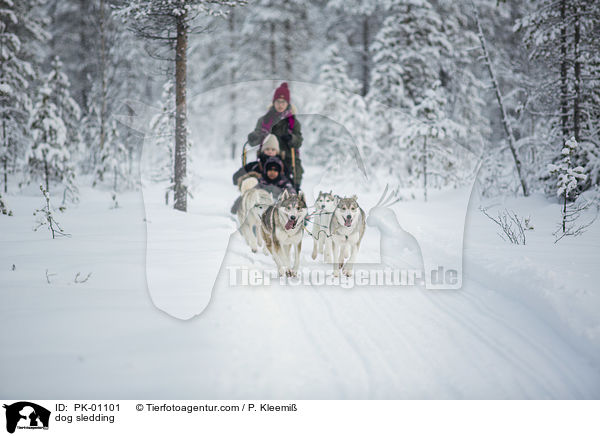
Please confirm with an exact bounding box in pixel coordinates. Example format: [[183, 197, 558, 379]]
[[174, 14, 188, 212]]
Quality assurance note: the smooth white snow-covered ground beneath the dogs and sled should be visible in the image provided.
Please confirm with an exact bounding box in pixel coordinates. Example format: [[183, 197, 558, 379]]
[[0, 162, 600, 399]]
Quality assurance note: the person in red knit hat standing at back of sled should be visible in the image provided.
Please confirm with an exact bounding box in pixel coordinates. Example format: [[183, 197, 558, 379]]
[[248, 82, 304, 190]]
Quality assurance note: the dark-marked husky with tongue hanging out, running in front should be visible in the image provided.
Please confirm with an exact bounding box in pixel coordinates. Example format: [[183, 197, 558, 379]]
[[261, 190, 307, 277]]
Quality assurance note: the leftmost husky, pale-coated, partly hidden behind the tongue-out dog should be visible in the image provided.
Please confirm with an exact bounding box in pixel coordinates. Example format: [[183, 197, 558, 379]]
[[237, 182, 274, 253]]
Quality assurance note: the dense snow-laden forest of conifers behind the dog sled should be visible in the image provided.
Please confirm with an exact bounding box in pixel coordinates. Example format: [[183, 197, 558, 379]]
[[0, 0, 600, 211]]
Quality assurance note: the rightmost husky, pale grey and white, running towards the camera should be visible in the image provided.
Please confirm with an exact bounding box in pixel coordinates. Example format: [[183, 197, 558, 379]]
[[329, 195, 366, 277]]
